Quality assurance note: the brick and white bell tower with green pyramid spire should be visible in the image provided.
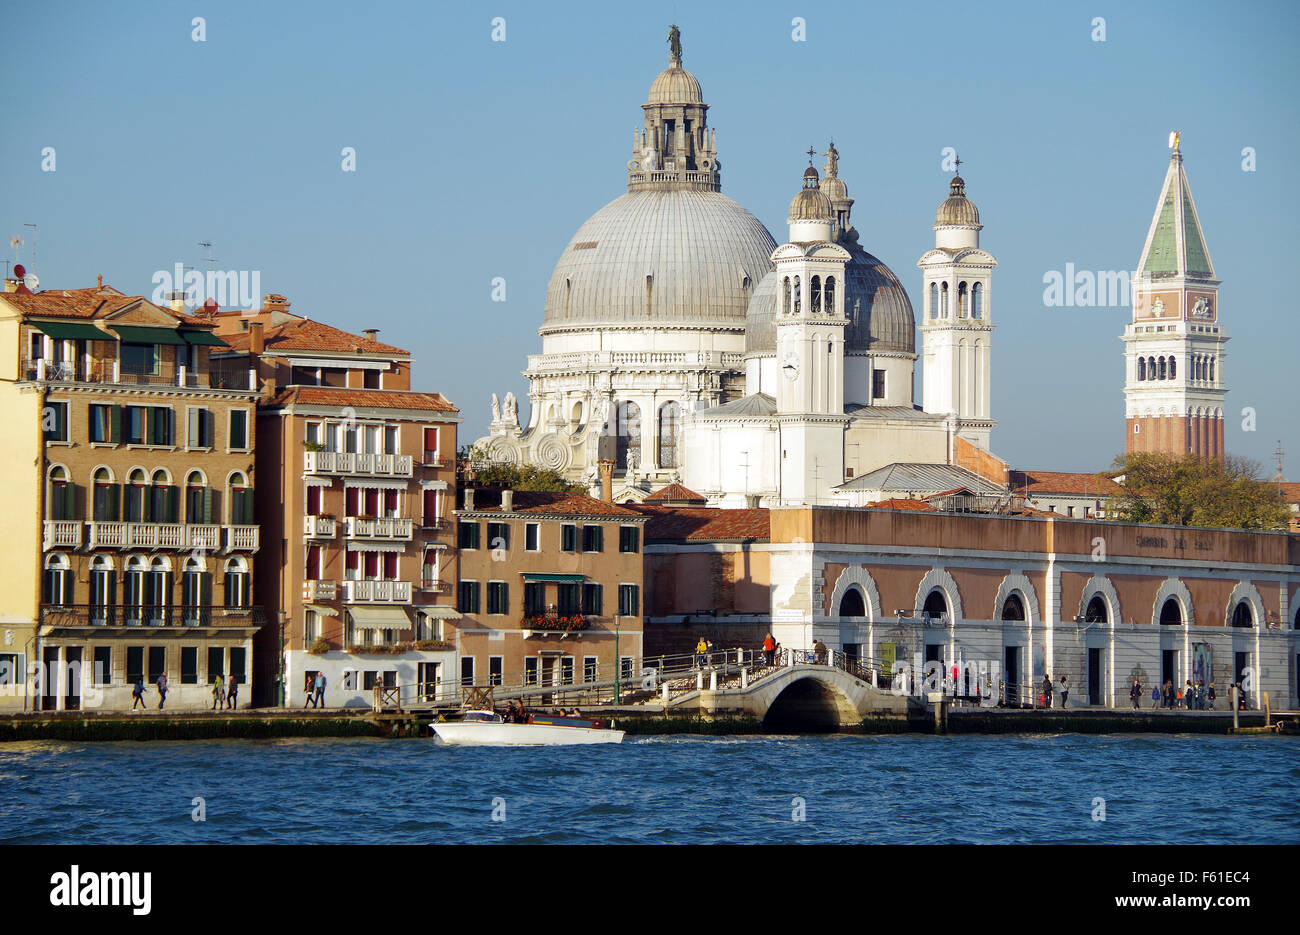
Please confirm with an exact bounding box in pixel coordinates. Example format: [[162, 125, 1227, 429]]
[[1123, 133, 1229, 458]]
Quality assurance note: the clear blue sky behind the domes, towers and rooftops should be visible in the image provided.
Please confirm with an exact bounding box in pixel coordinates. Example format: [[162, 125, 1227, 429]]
[[0, 0, 1300, 480]]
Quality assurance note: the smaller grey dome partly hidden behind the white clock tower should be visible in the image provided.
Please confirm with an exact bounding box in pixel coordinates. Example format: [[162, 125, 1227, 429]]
[[745, 229, 917, 355]]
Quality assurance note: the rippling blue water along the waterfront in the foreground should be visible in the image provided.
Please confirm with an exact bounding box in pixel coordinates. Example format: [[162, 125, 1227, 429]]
[[0, 735, 1300, 844]]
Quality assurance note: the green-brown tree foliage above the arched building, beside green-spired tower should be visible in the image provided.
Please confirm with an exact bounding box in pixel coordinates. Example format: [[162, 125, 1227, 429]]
[[1105, 451, 1288, 529]]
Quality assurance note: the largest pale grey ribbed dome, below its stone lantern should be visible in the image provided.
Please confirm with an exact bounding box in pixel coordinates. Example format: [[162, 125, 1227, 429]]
[[542, 189, 774, 330]]
